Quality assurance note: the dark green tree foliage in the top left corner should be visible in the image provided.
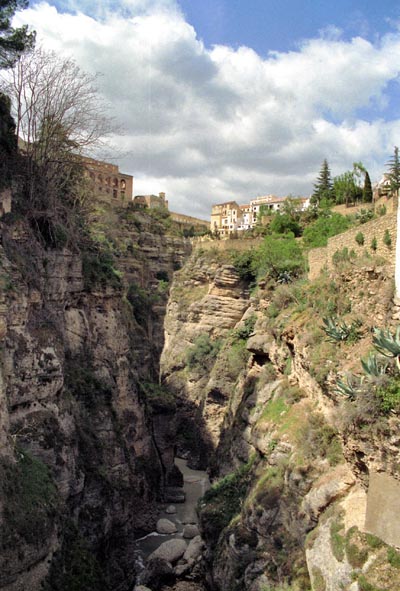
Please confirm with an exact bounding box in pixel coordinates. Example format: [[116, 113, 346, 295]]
[[0, 0, 35, 68]]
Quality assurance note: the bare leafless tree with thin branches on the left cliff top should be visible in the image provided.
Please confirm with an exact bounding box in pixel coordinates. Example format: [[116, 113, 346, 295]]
[[2, 47, 112, 214]]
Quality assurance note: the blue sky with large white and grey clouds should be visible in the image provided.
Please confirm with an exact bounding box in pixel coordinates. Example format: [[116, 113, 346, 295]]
[[9, 0, 400, 219]]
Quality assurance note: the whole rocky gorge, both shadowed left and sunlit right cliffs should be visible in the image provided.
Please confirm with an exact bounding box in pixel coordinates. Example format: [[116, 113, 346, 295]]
[[0, 194, 400, 591]]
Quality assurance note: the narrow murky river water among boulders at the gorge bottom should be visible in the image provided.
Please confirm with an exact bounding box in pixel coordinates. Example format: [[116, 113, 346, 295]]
[[136, 458, 210, 568]]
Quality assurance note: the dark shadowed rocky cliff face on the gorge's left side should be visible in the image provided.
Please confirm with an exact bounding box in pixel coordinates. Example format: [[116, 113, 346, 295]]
[[0, 210, 188, 591]]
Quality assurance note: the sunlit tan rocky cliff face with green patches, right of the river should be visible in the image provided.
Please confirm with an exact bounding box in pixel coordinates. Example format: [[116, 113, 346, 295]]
[[161, 252, 399, 591]]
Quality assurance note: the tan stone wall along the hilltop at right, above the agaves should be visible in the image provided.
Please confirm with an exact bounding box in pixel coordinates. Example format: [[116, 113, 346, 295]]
[[308, 212, 396, 279]]
